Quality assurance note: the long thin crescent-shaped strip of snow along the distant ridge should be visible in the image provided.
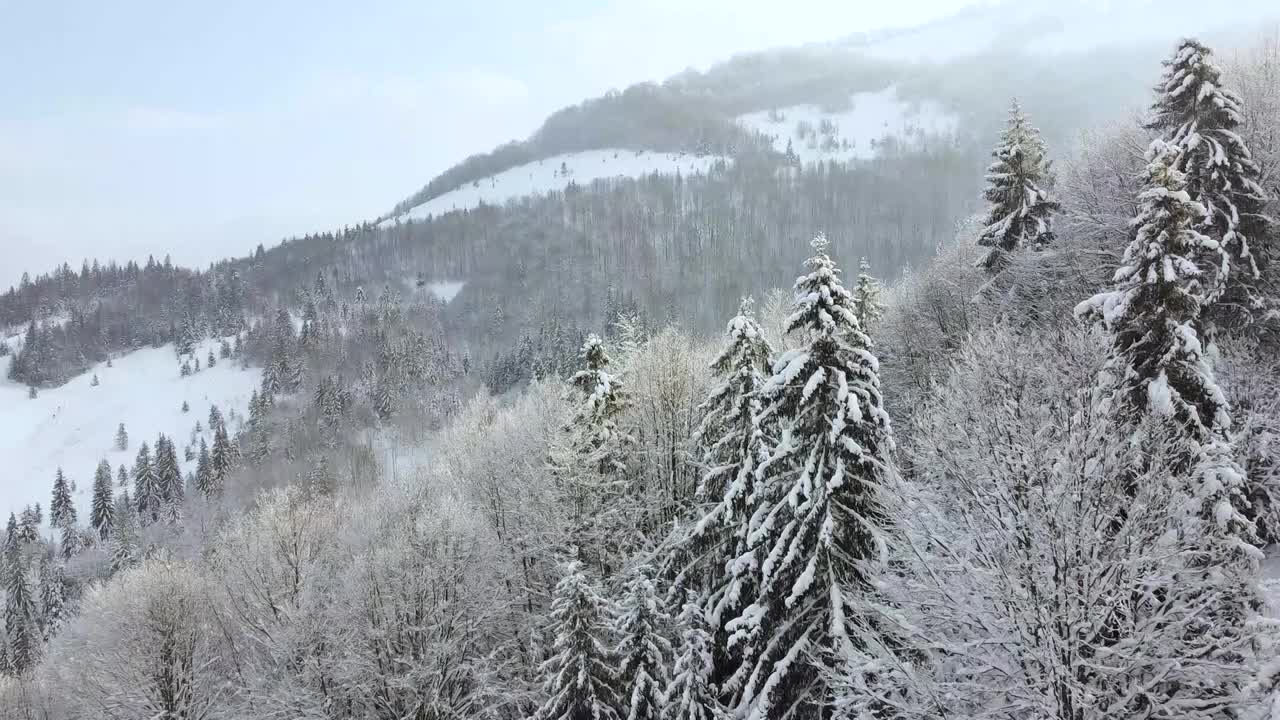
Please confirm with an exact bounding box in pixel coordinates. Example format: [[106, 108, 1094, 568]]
[[380, 149, 728, 227]]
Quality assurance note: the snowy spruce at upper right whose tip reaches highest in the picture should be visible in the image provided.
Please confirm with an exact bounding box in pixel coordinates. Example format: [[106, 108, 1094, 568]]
[[1147, 40, 1280, 324]]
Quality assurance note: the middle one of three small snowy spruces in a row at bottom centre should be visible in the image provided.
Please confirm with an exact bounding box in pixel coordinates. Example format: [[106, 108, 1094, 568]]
[[616, 569, 671, 720]]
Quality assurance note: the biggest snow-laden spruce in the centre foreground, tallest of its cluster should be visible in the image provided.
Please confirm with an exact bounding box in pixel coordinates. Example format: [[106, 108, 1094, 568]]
[[728, 236, 892, 720]]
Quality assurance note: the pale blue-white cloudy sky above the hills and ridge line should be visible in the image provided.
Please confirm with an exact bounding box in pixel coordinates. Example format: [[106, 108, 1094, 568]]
[[0, 0, 969, 287]]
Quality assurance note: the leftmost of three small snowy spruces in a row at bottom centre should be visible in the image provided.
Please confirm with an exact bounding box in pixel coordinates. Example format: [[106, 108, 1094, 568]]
[[534, 561, 620, 720]]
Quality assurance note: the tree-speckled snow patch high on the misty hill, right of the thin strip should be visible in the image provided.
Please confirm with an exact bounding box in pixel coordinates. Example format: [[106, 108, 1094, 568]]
[[737, 86, 959, 163]]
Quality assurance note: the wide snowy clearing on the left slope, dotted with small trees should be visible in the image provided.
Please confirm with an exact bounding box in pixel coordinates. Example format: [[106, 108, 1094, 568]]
[[0, 337, 261, 523]]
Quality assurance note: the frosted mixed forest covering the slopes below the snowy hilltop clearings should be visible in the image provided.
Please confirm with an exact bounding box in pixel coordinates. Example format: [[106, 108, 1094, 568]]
[[0, 32, 1280, 720]]
